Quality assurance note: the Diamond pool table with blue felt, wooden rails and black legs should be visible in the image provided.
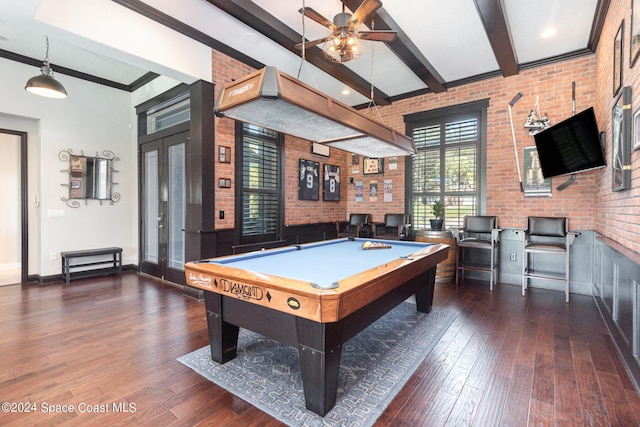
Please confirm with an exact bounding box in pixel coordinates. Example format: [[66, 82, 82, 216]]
[[185, 238, 448, 416]]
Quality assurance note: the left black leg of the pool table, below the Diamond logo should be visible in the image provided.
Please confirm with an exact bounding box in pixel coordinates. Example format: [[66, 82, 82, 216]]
[[204, 291, 240, 363]]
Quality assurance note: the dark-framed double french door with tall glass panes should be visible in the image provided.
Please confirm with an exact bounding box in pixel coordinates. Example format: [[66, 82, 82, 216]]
[[140, 132, 189, 285]]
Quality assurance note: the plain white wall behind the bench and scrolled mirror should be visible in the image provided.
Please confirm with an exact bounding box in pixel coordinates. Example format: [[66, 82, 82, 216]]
[[0, 58, 144, 276]]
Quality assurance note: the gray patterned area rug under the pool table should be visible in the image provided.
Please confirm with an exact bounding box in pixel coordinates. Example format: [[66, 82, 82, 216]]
[[178, 302, 456, 427]]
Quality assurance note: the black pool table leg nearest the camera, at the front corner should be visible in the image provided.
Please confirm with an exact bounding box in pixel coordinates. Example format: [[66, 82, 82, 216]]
[[296, 318, 344, 416]]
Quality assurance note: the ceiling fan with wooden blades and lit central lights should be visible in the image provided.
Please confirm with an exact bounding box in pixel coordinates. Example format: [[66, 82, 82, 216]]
[[296, 0, 396, 63]]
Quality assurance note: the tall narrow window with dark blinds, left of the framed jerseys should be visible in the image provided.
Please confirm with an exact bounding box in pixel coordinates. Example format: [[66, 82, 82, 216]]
[[239, 123, 282, 243]]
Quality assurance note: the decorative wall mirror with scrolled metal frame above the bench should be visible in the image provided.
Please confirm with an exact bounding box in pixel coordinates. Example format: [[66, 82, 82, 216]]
[[58, 149, 120, 208]]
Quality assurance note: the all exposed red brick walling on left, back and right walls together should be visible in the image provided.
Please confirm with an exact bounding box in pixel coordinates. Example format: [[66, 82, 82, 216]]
[[213, 2, 640, 252]]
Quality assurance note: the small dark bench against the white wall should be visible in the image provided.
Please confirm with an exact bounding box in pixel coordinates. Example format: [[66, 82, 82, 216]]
[[60, 248, 122, 285]]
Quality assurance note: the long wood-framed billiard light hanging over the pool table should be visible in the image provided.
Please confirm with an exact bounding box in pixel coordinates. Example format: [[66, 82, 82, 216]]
[[214, 67, 416, 157]]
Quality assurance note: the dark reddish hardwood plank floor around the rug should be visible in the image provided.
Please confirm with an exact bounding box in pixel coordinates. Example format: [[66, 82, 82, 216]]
[[0, 273, 640, 427]]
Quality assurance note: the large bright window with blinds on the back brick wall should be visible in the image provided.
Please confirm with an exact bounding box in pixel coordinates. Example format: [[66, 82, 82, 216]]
[[405, 101, 488, 230]]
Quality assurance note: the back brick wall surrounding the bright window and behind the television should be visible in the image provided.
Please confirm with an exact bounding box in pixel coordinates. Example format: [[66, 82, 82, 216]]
[[347, 55, 601, 229]]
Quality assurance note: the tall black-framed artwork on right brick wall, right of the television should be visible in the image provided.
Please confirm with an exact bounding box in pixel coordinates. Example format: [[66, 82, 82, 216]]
[[611, 86, 631, 191]]
